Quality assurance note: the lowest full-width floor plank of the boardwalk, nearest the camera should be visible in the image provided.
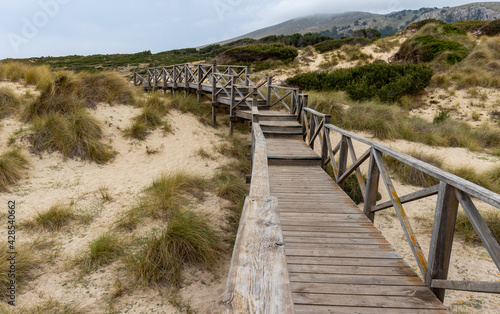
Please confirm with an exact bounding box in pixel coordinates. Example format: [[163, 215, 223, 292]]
[[293, 293, 445, 310]]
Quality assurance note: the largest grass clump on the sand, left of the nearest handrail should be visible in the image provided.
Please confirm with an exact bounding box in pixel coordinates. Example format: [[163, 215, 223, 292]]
[[128, 210, 221, 287]]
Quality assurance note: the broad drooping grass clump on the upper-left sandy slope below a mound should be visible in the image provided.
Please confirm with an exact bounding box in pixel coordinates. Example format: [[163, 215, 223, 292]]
[[29, 109, 115, 164]]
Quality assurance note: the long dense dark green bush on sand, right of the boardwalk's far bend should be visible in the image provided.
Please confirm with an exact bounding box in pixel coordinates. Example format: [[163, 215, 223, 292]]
[[287, 64, 434, 102]]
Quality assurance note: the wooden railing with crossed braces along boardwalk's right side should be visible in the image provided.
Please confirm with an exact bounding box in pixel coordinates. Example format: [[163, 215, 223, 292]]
[[301, 103, 500, 301]]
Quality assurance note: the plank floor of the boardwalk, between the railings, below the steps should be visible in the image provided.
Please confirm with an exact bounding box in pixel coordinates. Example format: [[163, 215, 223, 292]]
[[267, 112, 447, 313]]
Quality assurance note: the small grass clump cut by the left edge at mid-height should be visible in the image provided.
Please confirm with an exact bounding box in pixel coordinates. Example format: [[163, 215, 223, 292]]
[[0, 147, 29, 192]]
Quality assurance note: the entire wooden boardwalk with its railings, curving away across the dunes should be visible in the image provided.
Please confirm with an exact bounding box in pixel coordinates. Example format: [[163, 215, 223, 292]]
[[131, 64, 500, 313]]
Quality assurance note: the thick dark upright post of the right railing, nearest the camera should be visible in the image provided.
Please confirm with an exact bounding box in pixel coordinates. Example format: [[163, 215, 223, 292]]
[[425, 182, 458, 302]]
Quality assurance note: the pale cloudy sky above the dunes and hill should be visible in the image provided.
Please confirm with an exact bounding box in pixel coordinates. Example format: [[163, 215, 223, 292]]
[[0, 0, 486, 59]]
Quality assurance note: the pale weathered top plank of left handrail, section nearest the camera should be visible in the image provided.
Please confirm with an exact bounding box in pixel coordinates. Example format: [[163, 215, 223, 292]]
[[223, 197, 294, 313]]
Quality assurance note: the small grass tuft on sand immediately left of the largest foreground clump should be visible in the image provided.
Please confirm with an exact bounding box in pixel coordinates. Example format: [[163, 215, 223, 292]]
[[75, 233, 124, 273]]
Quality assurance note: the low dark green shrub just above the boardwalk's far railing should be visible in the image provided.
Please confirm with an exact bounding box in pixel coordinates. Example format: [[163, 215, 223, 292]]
[[217, 44, 299, 63]]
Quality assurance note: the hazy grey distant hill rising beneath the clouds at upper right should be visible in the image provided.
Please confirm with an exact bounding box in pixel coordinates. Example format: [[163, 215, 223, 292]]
[[221, 2, 500, 43]]
